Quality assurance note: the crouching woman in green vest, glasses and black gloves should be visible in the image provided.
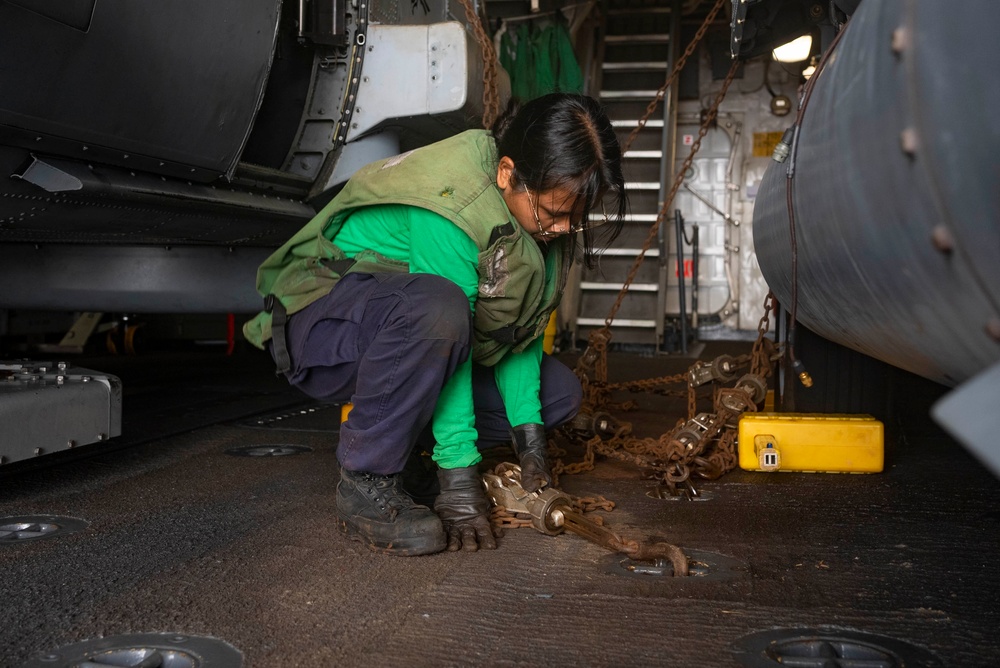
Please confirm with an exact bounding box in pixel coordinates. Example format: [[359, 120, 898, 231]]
[[244, 94, 626, 555]]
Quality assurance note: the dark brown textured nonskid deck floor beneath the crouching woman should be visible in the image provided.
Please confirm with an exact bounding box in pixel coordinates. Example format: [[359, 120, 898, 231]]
[[0, 342, 1000, 667]]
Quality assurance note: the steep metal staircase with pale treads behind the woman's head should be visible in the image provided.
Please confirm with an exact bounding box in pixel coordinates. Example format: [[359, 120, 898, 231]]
[[570, 0, 680, 350]]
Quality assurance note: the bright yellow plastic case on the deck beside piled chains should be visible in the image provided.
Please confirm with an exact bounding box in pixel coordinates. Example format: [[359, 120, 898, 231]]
[[738, 413, 885, 473]]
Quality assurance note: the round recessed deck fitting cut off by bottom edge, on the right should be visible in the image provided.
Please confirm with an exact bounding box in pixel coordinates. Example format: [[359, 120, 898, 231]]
[[733, 627, 942, 668]]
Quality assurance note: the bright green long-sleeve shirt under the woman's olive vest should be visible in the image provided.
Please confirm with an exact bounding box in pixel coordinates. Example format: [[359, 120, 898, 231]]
[[333, 204, 542, 468]]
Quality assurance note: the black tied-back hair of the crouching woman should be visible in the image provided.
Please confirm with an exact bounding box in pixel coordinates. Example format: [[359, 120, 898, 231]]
[[493, 93, 628, 266]]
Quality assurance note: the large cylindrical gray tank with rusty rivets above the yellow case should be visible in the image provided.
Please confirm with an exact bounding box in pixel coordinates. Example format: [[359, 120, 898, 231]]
[[753, 0, 1000, 385]]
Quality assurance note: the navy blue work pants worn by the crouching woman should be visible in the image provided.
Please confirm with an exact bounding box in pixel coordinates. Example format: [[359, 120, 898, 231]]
[[278, 273, 582, 475]]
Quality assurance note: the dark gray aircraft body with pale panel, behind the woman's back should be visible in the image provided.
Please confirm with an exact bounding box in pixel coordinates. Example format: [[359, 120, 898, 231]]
[[0, 0, 500, 313]]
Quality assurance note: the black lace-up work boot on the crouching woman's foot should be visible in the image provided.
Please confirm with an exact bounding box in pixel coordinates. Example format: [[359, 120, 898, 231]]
[[337, 468, 448, 556]]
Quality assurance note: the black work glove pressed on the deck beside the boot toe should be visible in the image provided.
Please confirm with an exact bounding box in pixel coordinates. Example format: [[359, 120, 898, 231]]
[[434, 466, 499, 552]]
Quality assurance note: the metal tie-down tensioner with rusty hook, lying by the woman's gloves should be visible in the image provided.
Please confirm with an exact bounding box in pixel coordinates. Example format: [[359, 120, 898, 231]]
[[483, 462, 688, 576]]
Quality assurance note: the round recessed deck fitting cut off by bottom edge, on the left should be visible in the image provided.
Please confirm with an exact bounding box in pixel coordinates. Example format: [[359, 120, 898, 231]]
[[22, 633, 243, 668]]
